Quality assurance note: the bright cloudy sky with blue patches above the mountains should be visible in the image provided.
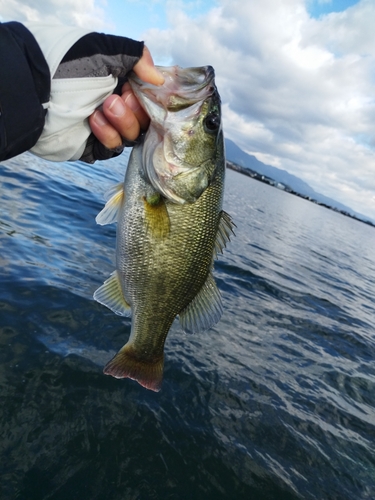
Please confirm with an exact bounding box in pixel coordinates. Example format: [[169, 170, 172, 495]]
[[0, 0, 375, 219]]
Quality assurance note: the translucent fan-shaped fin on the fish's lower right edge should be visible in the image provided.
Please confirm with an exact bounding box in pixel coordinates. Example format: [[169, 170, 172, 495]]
[[179, 272, 223, 333]]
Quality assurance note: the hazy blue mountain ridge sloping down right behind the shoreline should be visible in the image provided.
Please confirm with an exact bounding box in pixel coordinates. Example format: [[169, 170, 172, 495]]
[[225, 139, 369, 221]]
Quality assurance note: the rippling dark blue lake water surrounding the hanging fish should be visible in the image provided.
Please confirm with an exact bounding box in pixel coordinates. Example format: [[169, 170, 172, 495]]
[[0, 154, 375, 500]]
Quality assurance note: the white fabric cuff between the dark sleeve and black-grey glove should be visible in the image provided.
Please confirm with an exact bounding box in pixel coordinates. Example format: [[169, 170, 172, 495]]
[[25, 23, 118, 161]]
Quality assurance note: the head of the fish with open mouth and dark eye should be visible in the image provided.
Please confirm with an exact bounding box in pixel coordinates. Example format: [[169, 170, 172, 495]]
[[129, 66, 224, 204]]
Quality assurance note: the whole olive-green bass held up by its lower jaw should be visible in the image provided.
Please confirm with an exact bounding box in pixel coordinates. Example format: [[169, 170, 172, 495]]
[[94, 66, 234, 392]]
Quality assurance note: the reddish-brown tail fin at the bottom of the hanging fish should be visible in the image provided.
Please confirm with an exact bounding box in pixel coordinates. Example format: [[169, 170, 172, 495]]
[[103, 344, 164, 392]]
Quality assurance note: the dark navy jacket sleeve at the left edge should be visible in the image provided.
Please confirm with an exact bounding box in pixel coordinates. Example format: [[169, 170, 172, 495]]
[[0, 22, 51, 161]]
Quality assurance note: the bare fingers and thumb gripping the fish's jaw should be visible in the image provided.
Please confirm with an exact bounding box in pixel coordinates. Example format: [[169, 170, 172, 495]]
[[89, 46, 164, 149]]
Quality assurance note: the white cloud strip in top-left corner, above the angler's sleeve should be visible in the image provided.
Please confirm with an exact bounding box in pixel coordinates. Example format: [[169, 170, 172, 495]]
[[0, 0, 112, 30]]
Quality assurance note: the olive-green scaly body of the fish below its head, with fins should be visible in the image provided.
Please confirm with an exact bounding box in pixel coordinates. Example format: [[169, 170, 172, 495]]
[[94, 65, 232, 391]]
